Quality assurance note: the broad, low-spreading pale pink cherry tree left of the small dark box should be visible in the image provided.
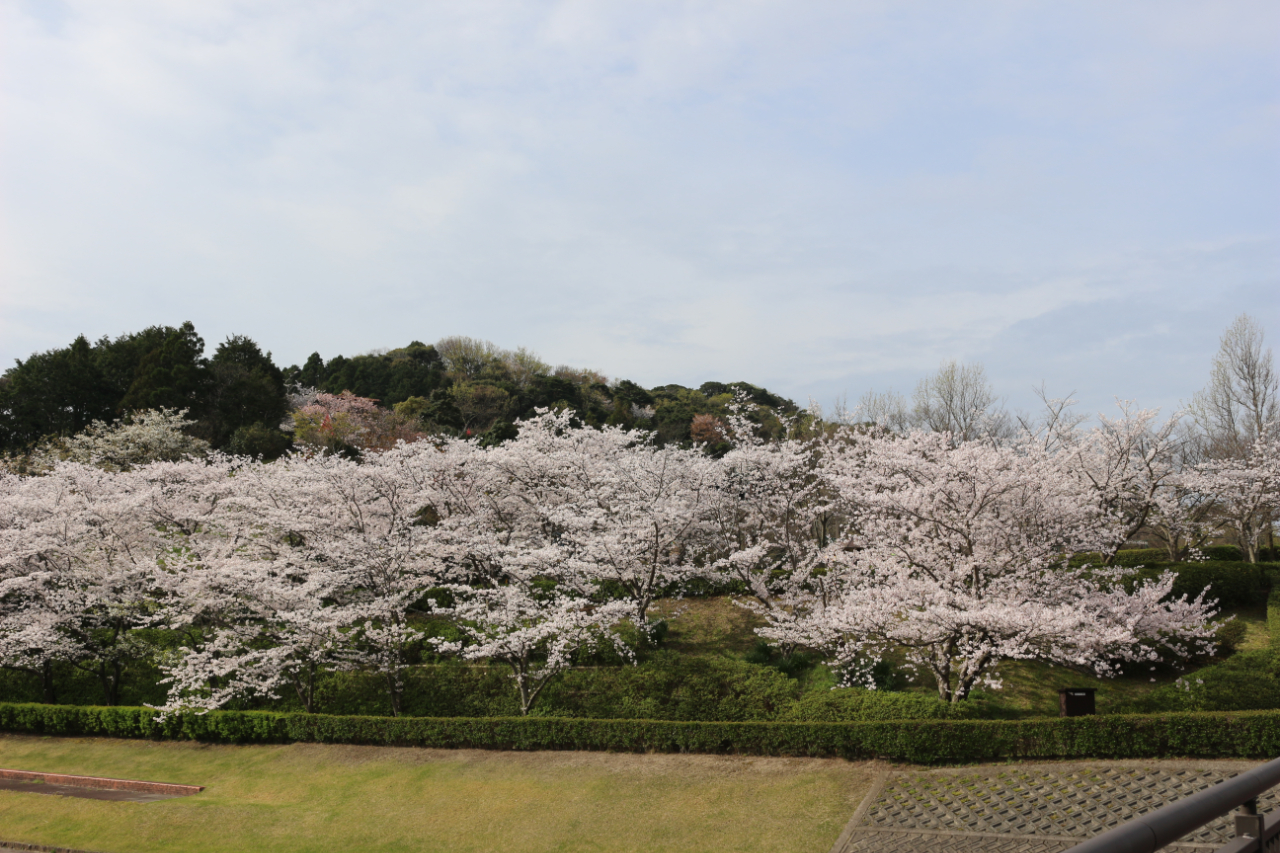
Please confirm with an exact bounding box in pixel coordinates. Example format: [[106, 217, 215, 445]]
[[788, 432, 1213, 702]]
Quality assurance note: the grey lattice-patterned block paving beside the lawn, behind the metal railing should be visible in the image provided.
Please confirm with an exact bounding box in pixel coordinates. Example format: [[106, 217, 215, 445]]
[[831, 761, 1280, 853]]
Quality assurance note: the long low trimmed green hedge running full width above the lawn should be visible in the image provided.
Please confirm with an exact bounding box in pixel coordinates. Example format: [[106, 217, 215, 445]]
[[0, 703, 1280, 765]]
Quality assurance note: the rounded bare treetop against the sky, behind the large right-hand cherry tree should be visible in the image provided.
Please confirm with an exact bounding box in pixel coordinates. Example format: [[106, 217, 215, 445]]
[[911, 361, 1011, 443]]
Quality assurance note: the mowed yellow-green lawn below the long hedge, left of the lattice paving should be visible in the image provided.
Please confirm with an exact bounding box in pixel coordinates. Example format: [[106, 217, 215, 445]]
[[0, 735, 877, 853]]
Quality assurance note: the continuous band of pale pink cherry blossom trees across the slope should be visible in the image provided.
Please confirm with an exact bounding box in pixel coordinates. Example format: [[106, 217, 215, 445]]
[[0, 398, 1277, 712]]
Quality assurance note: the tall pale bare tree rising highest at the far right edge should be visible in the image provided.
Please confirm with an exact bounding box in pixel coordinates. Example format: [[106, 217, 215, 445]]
[[1190, 314, 1280, 457]]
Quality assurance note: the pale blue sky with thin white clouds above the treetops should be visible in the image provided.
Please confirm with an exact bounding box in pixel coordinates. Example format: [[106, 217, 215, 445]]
[[0, 0, 1280, 411]]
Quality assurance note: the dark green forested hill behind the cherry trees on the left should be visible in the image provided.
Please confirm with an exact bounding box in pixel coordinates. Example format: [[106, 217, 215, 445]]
[[0, 321, 796, 452]]
